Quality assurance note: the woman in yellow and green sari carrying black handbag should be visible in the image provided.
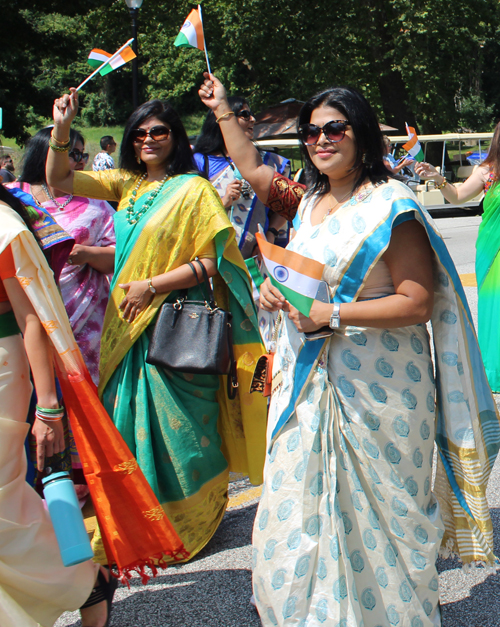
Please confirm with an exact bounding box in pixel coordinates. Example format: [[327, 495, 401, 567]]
[[47, 90, 266, 557]]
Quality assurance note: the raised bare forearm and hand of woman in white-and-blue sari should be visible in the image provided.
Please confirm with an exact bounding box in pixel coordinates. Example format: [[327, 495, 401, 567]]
[[198, 72, 274, 204]]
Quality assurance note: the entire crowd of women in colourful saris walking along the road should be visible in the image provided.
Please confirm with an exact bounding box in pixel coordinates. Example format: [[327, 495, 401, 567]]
[[0, 68, 500, 627]]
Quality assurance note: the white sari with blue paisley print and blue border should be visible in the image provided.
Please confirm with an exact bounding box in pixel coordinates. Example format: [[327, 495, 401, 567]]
[[253, 181, 500, 627]]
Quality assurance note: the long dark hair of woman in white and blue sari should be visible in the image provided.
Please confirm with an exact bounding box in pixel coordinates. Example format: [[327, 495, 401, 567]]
[[297, 87, 393, 194]]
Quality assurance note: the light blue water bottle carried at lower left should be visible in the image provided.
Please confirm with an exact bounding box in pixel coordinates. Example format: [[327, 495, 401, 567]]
[[42, 472, 94, 566]]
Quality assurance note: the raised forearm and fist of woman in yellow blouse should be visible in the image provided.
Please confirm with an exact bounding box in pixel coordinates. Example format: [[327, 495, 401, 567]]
[[45, 87, 78, 194]]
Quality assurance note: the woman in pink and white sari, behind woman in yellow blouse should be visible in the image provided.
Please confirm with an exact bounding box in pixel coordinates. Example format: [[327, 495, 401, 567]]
[[9, 128, 115, 385]]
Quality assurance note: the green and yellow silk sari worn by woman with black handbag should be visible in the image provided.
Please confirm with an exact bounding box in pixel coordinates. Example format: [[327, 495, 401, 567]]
[[96, 175, 266, 557]]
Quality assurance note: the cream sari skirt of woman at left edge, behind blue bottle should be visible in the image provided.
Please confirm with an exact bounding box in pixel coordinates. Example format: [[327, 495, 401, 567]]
[[0, 335, 97, 627]]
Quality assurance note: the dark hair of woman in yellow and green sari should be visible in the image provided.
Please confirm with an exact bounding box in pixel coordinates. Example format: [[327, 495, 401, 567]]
[[120, 100, 197, 175]]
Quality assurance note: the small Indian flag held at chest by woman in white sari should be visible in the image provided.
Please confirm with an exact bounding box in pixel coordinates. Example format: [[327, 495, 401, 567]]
[[255, 233, 325, 316]]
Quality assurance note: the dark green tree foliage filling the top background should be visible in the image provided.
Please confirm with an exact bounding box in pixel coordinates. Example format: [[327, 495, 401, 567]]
[[0, 0, 500, 142]]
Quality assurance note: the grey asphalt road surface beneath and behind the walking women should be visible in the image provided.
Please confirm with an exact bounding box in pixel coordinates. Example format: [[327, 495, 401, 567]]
[[56, 217, 500, 627]]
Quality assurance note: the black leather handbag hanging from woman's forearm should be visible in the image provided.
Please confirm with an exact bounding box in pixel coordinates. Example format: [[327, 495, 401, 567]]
[[146, 259, 238, 399]]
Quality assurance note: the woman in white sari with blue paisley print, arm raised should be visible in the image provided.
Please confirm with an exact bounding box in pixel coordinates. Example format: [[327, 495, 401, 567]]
[[200, 76, 500, 627]]
